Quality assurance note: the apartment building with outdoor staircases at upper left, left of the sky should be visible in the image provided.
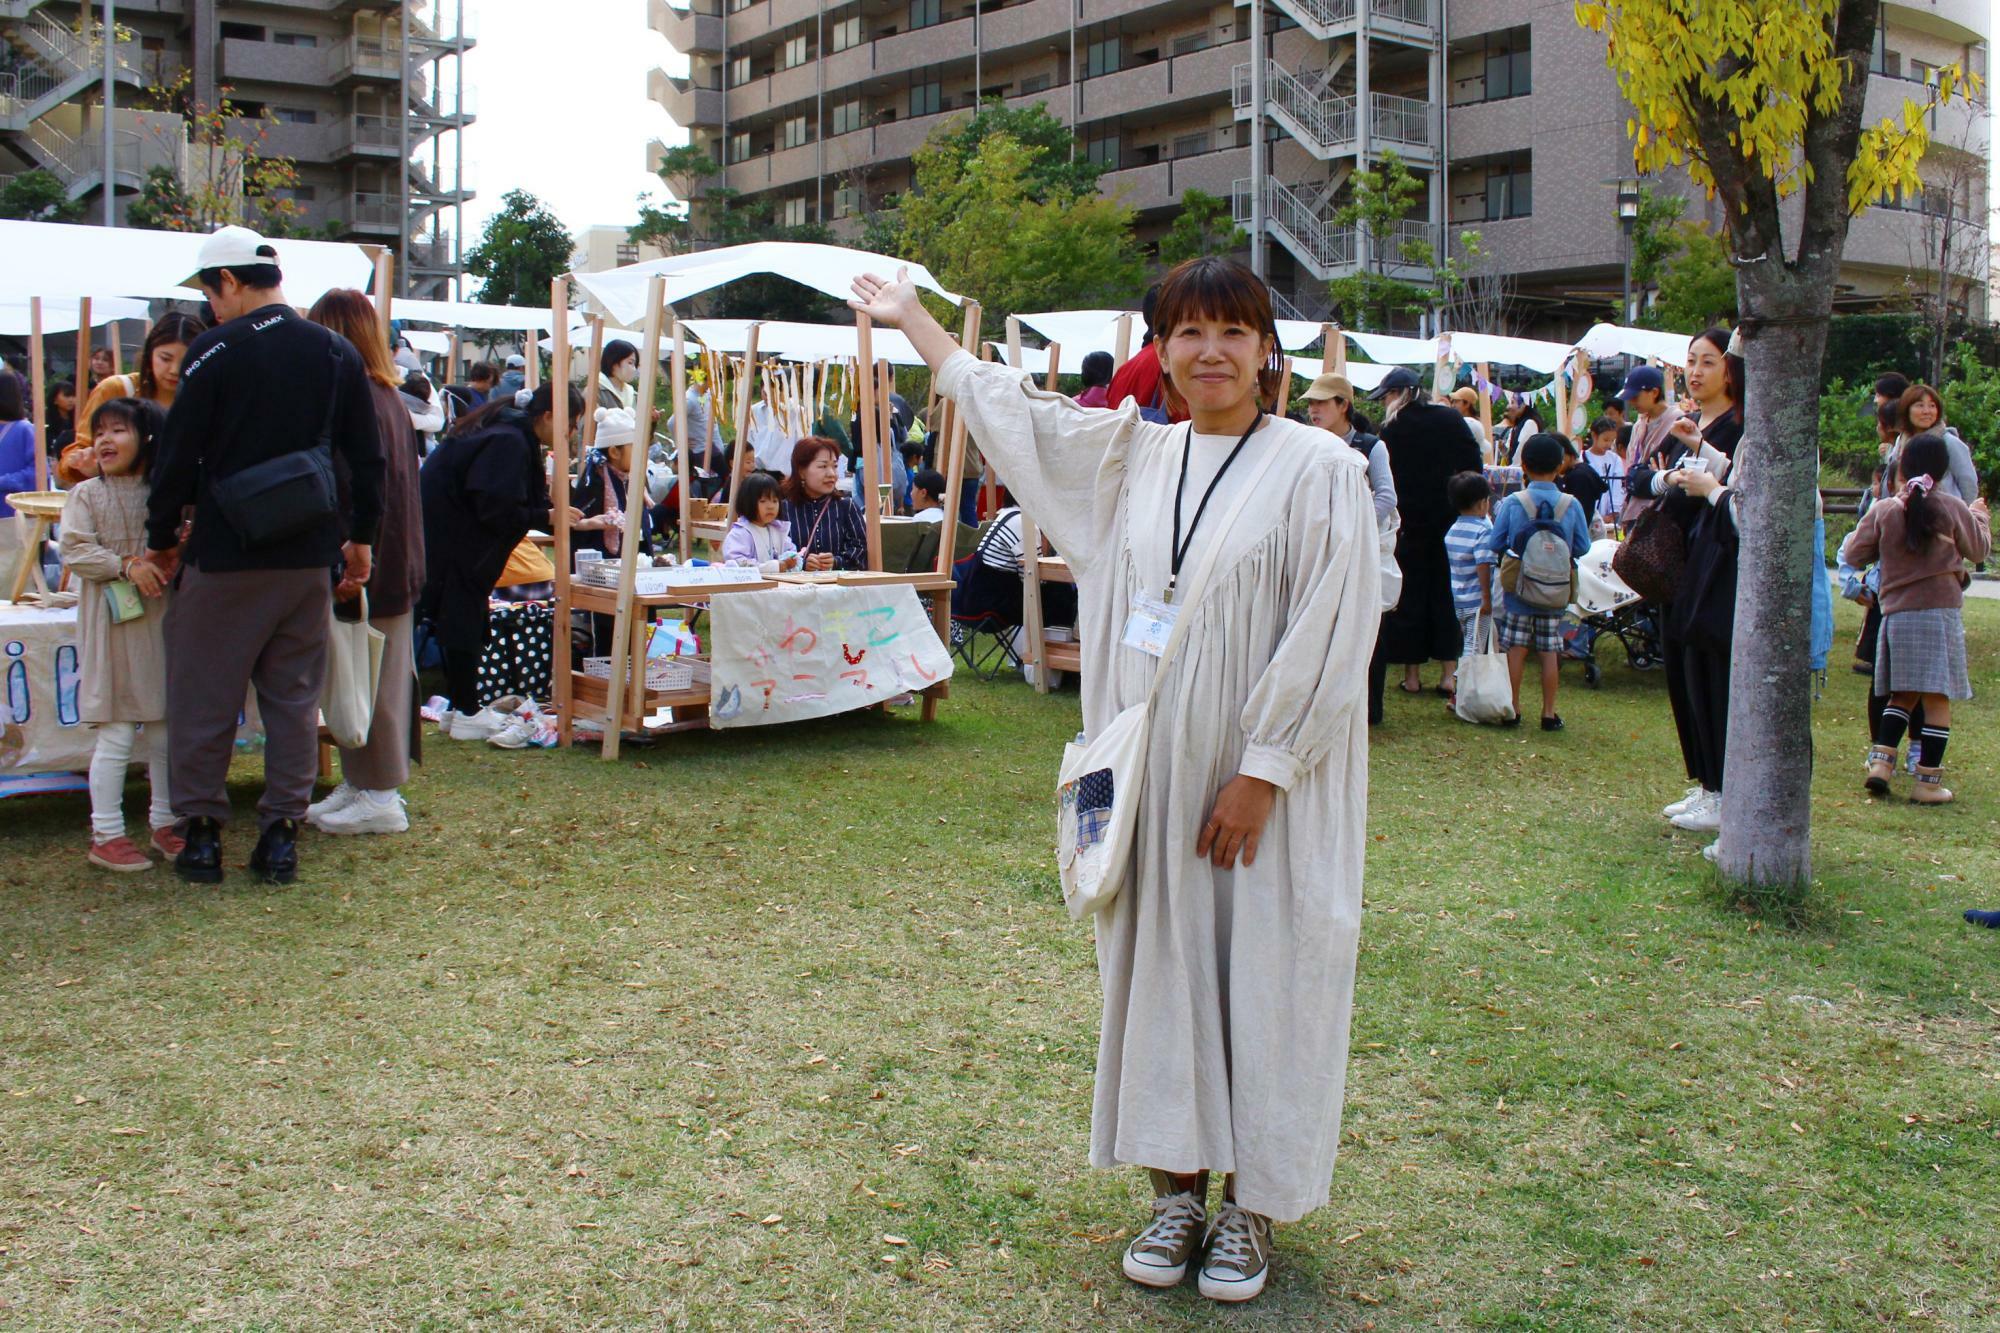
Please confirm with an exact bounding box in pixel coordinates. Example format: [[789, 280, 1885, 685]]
[[0, 0, 476, 296]]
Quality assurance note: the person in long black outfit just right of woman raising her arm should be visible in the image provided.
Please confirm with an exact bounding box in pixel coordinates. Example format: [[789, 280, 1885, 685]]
[[1356, 366, 1482, 723]]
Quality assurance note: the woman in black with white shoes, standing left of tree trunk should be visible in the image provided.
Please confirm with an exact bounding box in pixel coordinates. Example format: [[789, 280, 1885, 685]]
[[1626, 328, 1744, 833]]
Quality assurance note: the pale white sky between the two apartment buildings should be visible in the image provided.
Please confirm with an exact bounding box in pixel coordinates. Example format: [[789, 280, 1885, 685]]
[[466, 0, 686, 242]]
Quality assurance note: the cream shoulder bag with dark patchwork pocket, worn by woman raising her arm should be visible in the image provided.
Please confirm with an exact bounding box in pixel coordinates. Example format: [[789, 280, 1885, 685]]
[[1056, 434, 1284, 921]]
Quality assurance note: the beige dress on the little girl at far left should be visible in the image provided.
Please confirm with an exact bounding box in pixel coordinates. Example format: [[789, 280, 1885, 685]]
[[60, 476, 172, 723]]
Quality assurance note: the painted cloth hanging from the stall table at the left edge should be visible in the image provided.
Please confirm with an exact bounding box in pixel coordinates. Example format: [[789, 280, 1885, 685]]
[[0, 606, 98, 777]]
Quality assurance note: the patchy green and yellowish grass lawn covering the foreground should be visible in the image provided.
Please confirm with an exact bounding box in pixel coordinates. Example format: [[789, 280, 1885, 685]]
[[0, 602, 2000, 1331]]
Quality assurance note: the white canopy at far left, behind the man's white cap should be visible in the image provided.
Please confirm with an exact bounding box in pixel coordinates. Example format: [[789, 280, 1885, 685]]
[[0, 222, 374, 306]]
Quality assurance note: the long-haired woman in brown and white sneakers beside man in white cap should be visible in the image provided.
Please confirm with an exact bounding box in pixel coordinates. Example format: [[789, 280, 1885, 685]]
[[306, 288, 424, 833]]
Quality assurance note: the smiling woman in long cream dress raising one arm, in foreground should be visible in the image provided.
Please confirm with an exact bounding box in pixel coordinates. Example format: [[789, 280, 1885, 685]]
[[850, 258, 1382, 1301]]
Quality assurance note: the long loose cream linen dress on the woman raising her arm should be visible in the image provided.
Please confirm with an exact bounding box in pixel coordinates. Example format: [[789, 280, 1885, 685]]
[[938, 352, 1382, 1221]]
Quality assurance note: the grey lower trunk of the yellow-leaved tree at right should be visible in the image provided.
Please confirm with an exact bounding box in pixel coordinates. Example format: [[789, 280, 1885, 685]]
[[1716, 266, 1832, 887]]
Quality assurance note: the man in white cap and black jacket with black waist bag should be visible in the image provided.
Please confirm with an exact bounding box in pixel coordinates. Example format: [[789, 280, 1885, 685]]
[[146, 226, 382, 885]]
